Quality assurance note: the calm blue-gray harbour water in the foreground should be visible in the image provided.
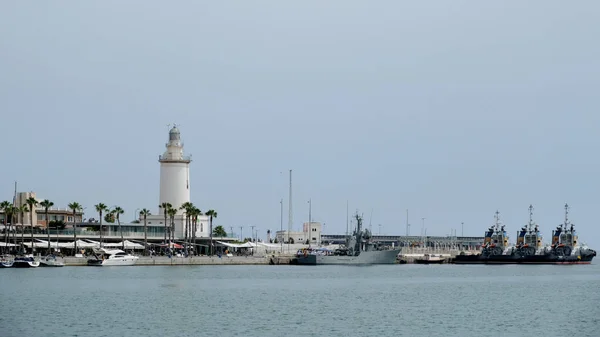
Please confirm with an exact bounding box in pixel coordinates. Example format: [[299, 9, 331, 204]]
[[0, 264, 600, 337]]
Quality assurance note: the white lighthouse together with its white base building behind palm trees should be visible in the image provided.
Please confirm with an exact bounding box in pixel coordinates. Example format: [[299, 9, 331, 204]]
[[147, 125, 210, 239]]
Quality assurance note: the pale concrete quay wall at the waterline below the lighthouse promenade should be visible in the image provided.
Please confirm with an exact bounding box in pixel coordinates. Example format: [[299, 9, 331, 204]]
[[64, 255, 291, 266]]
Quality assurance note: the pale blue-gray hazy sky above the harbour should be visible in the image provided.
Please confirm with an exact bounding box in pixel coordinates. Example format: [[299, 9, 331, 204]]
[[0, 0, 600, 245]]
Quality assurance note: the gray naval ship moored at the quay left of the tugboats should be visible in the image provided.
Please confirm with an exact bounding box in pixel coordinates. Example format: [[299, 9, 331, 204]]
[[292, 214, 400, 265]]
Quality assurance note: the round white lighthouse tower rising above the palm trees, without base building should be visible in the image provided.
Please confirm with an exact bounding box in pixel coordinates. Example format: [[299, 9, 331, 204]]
[[158, 125, 192, 215]]
